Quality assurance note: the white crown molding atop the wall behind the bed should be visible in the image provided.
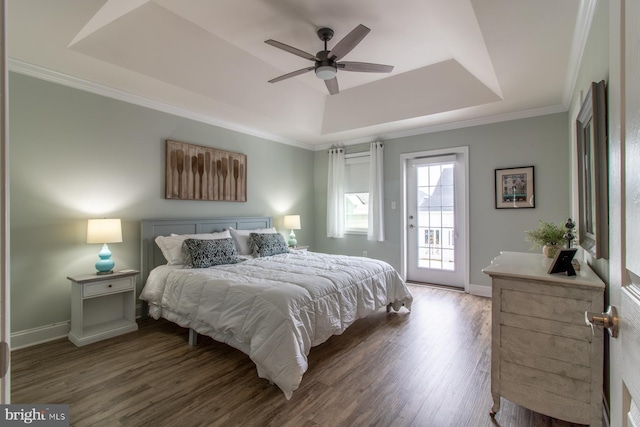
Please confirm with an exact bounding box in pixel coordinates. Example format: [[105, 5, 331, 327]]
[[7, 58, 314, 150]]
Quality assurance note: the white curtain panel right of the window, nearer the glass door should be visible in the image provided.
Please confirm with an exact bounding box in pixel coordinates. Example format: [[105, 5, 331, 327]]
[[367, 142, 384, 242]]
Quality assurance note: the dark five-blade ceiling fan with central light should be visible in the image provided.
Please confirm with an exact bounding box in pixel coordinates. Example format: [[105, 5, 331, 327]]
[[265, 24, 393, 95]]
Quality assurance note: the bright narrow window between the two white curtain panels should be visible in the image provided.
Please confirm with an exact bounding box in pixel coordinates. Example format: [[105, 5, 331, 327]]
[[344, 152, 369, 234]]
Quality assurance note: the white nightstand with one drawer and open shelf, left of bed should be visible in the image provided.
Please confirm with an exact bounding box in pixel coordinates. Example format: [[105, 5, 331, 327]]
[[67, 270, 139, 346]]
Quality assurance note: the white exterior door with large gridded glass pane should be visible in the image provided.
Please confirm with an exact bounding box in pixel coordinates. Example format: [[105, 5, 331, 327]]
[[405, 148, 467, 288]]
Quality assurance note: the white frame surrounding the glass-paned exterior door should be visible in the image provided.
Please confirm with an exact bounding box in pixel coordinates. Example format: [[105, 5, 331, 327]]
[[400, 146, 469, 293]]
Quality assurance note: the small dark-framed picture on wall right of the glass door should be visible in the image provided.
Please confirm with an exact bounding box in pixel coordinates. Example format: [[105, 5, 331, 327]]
[[495, 166, 536, 209]]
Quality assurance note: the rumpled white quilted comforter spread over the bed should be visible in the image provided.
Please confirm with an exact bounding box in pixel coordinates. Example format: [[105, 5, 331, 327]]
[[140, 251, 413, 399]]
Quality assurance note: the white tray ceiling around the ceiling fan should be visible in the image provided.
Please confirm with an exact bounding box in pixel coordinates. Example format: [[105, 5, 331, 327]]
[[7, 0, 595, 148]]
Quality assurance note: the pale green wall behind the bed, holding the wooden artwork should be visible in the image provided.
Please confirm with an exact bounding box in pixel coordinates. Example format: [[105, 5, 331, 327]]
[[9, 73, 314, 332]]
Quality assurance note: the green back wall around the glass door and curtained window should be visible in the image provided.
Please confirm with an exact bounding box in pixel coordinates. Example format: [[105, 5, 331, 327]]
[[314, 113, 571, 293]]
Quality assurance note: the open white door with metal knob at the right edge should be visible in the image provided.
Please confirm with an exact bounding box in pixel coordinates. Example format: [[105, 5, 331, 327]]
[[609, 0, 640, 427]]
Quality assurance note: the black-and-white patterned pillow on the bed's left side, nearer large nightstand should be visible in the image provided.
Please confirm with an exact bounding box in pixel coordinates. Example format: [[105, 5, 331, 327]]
[[182, 238, 240, 268]]
